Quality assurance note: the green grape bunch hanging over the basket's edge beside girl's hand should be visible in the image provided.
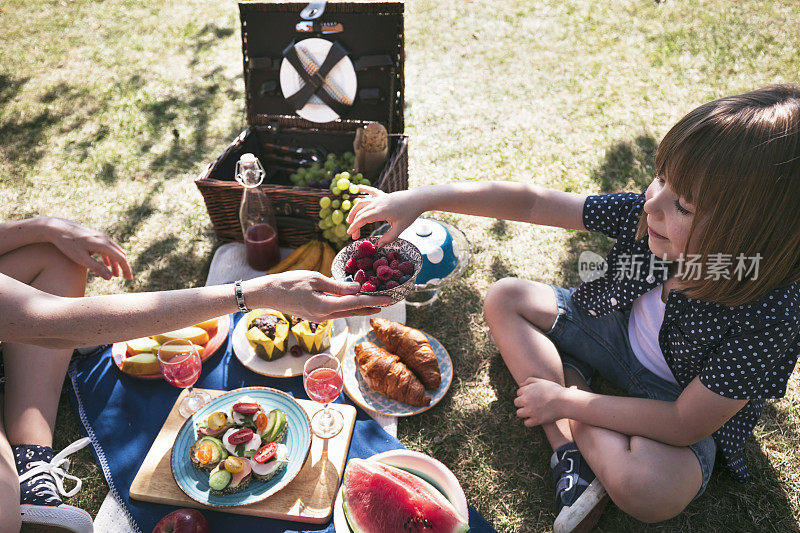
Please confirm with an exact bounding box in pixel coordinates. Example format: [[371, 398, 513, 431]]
[[317, 171, 370, 250]]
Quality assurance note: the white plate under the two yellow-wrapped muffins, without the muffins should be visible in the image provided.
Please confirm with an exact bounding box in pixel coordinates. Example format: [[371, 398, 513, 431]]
[[232, 315, 347, 378]]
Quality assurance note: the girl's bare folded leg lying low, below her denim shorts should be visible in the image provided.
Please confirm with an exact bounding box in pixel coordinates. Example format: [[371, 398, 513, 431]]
[[570, 420, 703, 522]]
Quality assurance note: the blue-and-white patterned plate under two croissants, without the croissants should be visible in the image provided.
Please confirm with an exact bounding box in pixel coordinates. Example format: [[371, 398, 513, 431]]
[[342, 331, 453, 416]]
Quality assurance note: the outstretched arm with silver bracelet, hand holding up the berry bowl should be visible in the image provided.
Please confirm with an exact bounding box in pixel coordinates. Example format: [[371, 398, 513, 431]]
[[0, 271, 391, 348]]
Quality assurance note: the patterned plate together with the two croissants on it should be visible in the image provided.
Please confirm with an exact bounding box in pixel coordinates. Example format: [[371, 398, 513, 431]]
[[342, 318, 453, 416]]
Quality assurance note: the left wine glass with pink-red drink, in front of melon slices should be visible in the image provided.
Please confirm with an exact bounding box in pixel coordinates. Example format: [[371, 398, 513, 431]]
[[158, 339, 211, 418]]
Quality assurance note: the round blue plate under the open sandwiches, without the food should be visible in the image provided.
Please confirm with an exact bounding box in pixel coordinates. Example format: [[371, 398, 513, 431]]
[[170, 387, 311, 507]]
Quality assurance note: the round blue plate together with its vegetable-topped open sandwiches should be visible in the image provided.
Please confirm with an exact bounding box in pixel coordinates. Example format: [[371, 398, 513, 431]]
[[170, 387, 311, 507]]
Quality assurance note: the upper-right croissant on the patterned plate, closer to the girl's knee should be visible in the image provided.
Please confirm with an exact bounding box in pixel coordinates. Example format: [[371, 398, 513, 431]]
[[369, 318, 442, 390]]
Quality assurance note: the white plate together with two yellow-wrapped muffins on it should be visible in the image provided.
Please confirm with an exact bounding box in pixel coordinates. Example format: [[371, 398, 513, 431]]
[[232, 309, 348, 377]]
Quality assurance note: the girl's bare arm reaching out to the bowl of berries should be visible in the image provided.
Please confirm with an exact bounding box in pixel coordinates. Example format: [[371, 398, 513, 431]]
[[347, 181, 586, 245]]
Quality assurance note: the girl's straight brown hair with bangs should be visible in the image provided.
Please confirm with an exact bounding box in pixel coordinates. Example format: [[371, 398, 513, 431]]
[[636, 84, 800, 306]]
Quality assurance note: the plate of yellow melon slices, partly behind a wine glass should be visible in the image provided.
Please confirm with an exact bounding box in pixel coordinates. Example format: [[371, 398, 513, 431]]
[[111, 315, 230, 379]]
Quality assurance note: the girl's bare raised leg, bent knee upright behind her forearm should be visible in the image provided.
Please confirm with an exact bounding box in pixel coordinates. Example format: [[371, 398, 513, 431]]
[[483, 278, 577, 450]]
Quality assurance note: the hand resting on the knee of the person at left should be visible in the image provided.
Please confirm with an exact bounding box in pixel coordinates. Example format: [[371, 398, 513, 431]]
[[47, 218, 133, 280]]
